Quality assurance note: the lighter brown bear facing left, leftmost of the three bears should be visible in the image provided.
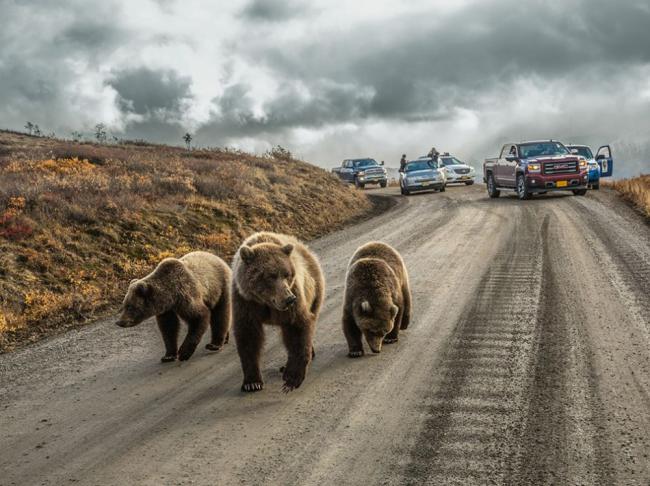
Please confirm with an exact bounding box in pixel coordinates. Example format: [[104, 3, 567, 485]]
[[117, 251, 232, 363]]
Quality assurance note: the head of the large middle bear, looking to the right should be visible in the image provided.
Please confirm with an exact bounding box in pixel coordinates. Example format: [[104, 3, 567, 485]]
[[235, 243, 298, 312]]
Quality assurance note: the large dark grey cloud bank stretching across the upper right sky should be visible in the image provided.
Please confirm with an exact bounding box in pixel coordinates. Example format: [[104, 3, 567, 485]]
[[227, 1, 650, 126]]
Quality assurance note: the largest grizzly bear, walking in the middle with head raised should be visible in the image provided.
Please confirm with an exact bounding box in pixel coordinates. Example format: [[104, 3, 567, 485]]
[[232, 232, 325, 392]]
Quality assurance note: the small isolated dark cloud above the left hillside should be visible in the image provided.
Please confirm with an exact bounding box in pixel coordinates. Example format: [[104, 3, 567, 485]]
[[107, 67, 192, 116]]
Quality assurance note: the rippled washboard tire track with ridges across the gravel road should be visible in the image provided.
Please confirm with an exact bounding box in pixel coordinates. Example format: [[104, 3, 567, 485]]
[[405, 209, 542, 485]]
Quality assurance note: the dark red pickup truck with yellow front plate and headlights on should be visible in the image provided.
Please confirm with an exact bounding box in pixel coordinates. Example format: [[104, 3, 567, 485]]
[[483, 140, 589, 199]]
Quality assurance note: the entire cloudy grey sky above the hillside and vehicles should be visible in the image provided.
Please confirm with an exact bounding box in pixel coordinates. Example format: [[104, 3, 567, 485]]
[[0, 0, 650, 175]]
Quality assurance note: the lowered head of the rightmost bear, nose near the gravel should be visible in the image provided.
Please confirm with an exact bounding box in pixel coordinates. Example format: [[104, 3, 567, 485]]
[[352, 297, 399, 353]]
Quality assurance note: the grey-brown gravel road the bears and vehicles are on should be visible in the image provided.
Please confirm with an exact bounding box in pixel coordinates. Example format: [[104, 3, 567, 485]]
[[0, 185, 650, 486]]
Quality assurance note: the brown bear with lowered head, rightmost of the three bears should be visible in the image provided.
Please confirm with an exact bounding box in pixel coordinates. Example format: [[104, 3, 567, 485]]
[[343, 241, 411, 358]]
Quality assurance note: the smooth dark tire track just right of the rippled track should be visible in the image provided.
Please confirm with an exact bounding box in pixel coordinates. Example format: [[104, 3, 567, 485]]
[[507, 211, 612, 485]]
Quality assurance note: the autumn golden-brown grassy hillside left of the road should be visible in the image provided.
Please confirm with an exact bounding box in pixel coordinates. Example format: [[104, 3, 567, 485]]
[[0, 132, 372, 351]]
